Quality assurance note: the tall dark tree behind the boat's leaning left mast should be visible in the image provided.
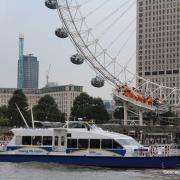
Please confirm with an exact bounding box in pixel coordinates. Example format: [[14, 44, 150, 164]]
[[8, 89, 30, 127]]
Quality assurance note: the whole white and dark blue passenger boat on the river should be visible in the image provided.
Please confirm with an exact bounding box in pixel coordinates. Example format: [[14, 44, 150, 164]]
[[0, 121, 180, 168]]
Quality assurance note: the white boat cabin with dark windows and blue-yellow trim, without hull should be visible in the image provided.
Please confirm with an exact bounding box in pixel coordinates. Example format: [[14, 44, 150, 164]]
[[4, 121, 142, 155]]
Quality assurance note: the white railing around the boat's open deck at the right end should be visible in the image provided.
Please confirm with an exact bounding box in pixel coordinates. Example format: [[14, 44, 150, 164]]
[[135, 144, 180, 157]]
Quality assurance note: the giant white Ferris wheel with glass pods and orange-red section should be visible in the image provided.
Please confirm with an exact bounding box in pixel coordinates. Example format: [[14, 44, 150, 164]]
[[45, 0, 180, 117]]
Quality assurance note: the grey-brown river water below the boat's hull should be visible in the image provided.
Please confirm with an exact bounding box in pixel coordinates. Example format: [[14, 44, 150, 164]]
[[0, 163, 180, 180]]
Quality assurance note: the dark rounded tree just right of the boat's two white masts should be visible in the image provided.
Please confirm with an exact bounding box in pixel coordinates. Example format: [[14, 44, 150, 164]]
[[33, 95, 65, 122]]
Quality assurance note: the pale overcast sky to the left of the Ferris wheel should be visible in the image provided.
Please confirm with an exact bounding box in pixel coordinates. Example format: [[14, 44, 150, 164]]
[[0, 0, 135, 99]]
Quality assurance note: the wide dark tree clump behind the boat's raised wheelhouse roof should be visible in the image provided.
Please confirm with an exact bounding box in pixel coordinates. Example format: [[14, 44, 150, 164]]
[[71, 92, 109, 123]]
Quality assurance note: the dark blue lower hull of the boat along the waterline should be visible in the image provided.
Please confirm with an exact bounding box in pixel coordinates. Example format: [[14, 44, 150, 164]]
[[0, 154, 178, 168]]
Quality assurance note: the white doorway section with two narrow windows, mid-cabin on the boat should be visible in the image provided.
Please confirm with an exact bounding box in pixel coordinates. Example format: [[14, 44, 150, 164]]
[[54, 129, 67, 152]]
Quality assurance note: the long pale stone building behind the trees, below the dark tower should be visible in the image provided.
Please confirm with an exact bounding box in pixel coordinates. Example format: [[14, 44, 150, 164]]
[[0, 85, 83, 119]]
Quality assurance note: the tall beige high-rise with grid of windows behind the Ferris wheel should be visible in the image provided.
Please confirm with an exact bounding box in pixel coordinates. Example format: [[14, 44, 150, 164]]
[[136, 0, 180, 105]]
